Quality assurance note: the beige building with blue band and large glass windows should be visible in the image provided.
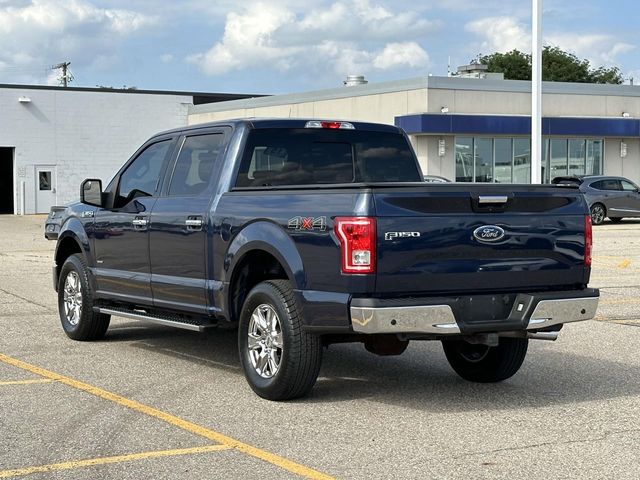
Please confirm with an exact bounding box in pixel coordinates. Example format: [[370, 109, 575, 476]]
[[188, 76, 640, 188]]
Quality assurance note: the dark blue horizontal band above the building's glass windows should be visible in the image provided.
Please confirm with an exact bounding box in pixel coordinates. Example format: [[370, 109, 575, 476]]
[[395, 113, 640, 138]]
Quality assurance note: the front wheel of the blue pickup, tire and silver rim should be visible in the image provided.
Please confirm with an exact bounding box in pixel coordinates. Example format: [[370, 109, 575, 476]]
[[58, 254, 111, 341]]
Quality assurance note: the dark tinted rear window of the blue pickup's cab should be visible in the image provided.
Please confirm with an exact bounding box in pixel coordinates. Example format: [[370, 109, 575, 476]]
[[236, 128, 421, 187]]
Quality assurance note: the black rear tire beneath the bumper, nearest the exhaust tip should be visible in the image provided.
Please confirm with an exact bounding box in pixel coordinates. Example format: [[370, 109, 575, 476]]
[[442, 337, 529, 383]]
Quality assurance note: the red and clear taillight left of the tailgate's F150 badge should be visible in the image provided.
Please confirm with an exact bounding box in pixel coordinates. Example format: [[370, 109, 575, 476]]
[[333, 217, 376, 273]]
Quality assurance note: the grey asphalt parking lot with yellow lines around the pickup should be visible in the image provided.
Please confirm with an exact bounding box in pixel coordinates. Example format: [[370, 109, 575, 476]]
[[0, 216, 640, 479]]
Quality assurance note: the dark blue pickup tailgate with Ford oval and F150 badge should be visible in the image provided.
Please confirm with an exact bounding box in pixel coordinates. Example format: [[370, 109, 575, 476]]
[[374, 184, 589, 295]]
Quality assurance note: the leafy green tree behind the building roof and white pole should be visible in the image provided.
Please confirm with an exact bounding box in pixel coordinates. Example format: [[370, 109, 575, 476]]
[[480, 45, 623, 84]]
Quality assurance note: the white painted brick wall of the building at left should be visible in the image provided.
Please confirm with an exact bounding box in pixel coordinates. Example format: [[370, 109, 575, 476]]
[[0, 88, 192, 213]]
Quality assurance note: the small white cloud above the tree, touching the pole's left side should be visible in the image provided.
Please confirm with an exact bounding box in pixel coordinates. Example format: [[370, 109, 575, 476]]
[[464, 16, 531, 53]]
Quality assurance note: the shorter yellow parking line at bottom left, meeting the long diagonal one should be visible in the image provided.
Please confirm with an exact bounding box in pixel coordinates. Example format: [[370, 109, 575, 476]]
[[0, 445, 231, 478]]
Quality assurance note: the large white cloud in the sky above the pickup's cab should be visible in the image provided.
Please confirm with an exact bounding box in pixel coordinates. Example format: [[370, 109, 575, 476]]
[[187, 0, 437, 75]]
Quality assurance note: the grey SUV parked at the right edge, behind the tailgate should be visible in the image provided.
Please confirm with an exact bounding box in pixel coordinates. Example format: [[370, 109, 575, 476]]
[[551, 175, 640, 225]]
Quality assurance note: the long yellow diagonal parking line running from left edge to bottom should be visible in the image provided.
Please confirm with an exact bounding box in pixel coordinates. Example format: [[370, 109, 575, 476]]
[[0, 353, 333, 480]]
